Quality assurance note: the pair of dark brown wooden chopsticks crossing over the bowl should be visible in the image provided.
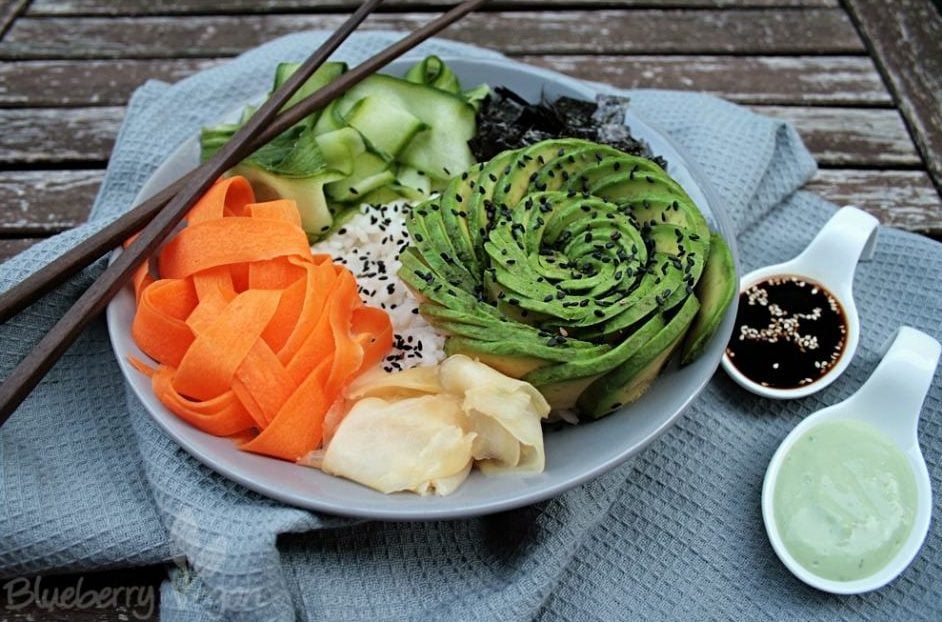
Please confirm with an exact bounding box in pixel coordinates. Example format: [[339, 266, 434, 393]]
[[0, 0, 487, 425]]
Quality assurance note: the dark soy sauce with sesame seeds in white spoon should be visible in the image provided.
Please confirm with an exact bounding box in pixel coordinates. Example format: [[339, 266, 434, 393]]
[[726, 276, 847, 389]]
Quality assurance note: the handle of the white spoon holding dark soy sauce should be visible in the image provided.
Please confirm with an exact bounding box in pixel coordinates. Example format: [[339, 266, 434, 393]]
[[795, 205, 880, 300]]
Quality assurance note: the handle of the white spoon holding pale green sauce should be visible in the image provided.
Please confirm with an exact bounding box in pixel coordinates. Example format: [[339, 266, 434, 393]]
[[849, 326, 942, 448]]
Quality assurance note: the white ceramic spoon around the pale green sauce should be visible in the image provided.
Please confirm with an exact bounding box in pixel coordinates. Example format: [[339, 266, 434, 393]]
[[762, 326, 942, 594]]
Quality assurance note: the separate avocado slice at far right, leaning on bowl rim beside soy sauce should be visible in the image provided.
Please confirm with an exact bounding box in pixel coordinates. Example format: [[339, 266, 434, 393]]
[[680, 233, 739, 365]]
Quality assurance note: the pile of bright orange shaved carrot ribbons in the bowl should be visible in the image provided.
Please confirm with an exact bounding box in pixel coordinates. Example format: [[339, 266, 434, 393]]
[[131, 177, 392, 460]]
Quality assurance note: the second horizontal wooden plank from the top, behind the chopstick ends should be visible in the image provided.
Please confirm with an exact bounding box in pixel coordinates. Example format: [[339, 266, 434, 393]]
[[0, 8, 864, 59]]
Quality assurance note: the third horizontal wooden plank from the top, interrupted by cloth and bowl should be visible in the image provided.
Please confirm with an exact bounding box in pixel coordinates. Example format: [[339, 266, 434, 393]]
[[0, 55, 892, 107]]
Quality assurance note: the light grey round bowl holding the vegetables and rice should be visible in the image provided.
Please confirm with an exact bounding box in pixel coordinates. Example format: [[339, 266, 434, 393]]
[[107, 58, 738, 520]]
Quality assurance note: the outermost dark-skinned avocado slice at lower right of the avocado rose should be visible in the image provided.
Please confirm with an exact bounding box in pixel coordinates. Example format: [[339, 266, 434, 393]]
[[576, 295, 700, 419]]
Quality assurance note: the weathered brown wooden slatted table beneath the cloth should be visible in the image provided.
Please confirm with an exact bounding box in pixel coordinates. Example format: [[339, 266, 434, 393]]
[[0, 0, 942, 620]]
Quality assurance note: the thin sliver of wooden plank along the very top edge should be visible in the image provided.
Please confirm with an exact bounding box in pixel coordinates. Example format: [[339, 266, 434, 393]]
[[28, 0, 839, 16]]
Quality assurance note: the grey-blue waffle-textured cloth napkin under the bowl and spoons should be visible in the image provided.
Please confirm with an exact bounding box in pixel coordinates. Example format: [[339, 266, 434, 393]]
[[0, 32, 942, 621]]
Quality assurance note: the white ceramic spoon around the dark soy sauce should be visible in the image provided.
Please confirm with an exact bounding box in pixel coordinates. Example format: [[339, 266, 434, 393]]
[[723, 206, 880, 399]]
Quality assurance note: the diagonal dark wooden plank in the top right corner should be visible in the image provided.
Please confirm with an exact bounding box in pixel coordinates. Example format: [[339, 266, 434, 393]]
[[847, 0, 942, 192]]
